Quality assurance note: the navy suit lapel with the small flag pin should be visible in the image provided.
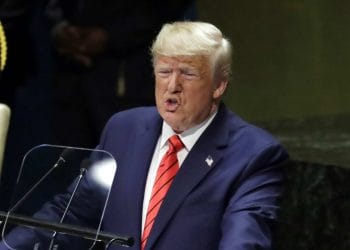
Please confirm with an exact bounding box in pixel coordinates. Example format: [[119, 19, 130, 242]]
[[146, 104, 229, 249]]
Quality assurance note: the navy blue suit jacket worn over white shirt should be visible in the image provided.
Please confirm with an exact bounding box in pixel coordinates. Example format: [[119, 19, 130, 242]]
[[0, 105, 288, 250]]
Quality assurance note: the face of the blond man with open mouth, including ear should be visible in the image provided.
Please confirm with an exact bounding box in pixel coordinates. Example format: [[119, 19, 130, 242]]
[[154, 56, 227, 133]]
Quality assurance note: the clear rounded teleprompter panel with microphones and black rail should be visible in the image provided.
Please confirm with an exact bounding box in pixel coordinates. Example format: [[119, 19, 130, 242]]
[[0, 145, 133, 250]]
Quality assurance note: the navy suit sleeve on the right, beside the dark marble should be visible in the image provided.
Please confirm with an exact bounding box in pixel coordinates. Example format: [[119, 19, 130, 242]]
[[219, 145, 288, 250]]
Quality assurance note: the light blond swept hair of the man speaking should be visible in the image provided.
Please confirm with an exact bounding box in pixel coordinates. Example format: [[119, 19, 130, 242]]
[[151, 21, 231, 80]]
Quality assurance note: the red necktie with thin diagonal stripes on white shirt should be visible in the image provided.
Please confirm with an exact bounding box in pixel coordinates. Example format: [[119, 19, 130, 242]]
[[141, 135, 184, 250]]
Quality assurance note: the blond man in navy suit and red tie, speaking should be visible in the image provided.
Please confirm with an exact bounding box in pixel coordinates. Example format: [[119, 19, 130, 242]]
[[0, 22, 287, 250]]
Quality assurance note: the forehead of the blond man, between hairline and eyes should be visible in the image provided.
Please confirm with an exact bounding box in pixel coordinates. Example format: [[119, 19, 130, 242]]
[[154, 55, 209, 70]]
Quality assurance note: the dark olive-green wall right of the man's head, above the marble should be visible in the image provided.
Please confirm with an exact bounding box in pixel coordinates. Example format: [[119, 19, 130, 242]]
[[198, 0, 350, 120]]
